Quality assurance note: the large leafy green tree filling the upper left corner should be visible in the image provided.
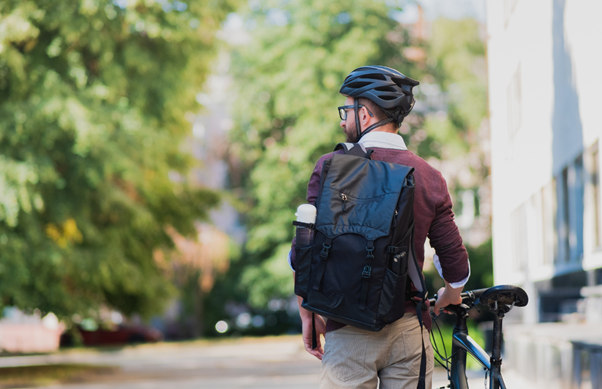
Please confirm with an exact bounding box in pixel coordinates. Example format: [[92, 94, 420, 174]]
[[0, 0, 234, 316]]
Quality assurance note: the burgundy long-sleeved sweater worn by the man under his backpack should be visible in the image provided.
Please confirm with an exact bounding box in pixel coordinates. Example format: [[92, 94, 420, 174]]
[[291, 148, 468, 332]]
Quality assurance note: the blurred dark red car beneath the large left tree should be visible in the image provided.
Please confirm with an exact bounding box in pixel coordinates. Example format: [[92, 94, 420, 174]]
[[61, 325, 163, 346]]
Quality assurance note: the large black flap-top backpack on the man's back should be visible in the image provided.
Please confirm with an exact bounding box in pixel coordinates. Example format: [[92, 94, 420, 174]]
[[293, 143, 426, 388]]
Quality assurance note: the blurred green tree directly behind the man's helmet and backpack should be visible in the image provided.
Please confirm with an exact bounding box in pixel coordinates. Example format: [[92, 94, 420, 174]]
[[231, 0, 422, 306]]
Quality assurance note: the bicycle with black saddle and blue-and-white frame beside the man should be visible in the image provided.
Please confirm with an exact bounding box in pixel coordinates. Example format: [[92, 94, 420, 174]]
[[429, 285, 529, 389]]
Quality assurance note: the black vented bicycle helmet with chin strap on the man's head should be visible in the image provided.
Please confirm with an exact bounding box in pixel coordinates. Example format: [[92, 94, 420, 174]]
[[339, 65, 420, 140]]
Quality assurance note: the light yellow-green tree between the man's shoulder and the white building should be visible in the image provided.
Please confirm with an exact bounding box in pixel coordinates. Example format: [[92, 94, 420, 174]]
[[417, 18, 490, 205]]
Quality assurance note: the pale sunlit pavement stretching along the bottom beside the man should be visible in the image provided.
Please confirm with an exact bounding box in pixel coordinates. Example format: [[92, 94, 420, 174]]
[[0, 336, 527, 389]]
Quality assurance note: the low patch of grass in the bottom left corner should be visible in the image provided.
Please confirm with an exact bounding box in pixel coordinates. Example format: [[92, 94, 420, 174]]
[[0, 364, 118, 388]]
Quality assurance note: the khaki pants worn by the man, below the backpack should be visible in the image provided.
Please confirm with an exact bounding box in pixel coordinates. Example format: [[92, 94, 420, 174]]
[[320, 313, 434, 389]]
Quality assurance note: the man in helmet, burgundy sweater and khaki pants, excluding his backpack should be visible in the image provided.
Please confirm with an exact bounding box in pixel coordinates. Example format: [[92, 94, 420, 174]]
[[291, 66, 470, 389]]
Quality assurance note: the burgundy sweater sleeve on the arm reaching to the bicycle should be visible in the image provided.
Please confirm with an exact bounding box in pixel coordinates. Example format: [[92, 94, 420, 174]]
[[428, 177, 470, 283]]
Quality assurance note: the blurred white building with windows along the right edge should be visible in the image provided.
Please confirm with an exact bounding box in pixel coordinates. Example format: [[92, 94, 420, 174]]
[[487, 0, 602, 323]]
